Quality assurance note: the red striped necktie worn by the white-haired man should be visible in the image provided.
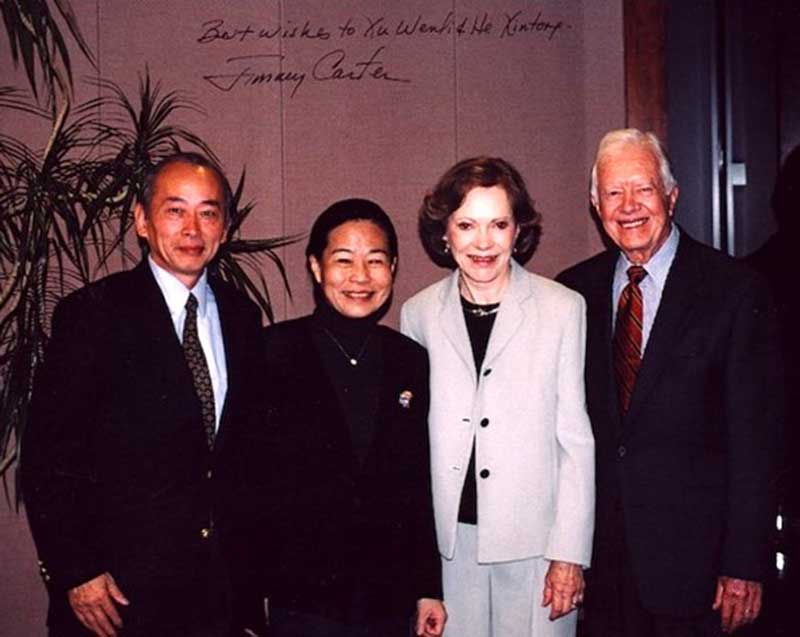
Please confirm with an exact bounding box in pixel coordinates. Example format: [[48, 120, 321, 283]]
[[614, 265, 647, 415]]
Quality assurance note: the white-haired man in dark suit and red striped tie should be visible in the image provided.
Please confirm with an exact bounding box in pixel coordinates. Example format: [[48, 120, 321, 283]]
[[559, 129, 781, 637]]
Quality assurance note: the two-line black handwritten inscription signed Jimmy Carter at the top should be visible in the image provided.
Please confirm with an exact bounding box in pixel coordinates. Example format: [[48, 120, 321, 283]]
[[196, 9, 572, 97]]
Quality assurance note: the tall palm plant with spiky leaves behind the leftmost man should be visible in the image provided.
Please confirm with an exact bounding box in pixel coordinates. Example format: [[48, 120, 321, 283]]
[[0, 0, 299, 485]]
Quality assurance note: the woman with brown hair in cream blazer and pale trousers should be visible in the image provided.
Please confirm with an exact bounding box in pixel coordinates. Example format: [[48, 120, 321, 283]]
[[401, 157, 594, 637]]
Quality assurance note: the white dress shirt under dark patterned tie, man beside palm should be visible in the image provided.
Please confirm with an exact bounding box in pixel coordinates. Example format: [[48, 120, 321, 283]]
[[147, 257, 228, 431]]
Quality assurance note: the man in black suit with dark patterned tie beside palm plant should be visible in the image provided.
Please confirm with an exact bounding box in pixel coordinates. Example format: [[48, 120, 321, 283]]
[[22, 153, 261, 637]]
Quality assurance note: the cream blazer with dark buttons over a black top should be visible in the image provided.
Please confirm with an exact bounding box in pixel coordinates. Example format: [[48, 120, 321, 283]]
[[400, 263, 594, 566]]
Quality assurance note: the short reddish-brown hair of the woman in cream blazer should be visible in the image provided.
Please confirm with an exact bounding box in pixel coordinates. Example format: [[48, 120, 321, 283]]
[[419, 156, 542, 269]]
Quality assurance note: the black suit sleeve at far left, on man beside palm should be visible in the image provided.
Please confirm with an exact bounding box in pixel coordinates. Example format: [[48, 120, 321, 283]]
[[21, 295, 106, 590]]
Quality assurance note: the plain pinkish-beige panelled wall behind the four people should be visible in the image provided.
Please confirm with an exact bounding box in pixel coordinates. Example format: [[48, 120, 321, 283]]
[[0, 0, 624, 637]]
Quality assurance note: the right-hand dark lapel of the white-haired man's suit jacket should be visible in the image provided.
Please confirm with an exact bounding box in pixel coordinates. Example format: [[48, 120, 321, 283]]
[[625, 233, 701, 423]]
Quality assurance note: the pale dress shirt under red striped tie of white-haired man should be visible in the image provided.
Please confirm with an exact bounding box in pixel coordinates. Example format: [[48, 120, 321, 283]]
[[611, 223, 680, 356]]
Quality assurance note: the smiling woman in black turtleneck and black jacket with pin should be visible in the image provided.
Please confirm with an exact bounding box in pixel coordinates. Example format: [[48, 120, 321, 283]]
[[264, 199, 446, 637]]
